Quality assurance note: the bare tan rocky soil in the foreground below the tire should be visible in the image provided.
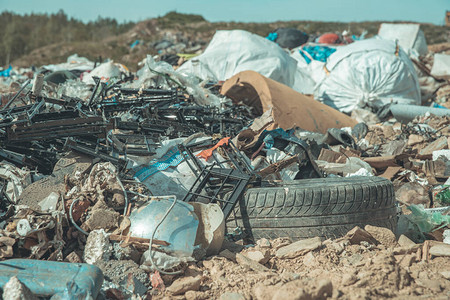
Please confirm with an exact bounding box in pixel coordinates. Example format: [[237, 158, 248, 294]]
[[141, 226, 450, 300]]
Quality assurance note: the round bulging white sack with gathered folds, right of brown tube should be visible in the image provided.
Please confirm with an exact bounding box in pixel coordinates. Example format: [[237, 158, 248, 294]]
[[314, 39, 421, 113]]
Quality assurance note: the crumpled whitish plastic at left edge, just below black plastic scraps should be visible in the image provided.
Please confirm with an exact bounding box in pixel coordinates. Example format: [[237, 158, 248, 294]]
[[0, 163, 31, 203]]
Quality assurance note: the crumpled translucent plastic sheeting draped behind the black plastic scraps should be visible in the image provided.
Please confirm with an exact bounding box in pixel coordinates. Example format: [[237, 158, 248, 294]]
[[129, 55, 221, 106]]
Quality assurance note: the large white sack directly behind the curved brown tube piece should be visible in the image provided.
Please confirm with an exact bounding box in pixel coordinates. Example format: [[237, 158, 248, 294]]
[[177, 30, 297, 87]]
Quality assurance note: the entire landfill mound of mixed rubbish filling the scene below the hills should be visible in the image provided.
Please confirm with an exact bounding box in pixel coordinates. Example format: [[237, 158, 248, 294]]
[[0, 24, 450, 300]]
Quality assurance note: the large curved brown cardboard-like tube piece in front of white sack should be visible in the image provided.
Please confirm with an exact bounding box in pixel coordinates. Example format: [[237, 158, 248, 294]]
[[221, 71, 356, 133]]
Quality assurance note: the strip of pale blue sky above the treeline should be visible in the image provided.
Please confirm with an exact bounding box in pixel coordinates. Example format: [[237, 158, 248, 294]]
[[0, 0, 450, 25]]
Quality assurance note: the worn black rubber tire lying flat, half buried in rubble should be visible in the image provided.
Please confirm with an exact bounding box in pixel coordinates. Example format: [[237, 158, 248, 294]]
[[226, 177, 397, 240]]
